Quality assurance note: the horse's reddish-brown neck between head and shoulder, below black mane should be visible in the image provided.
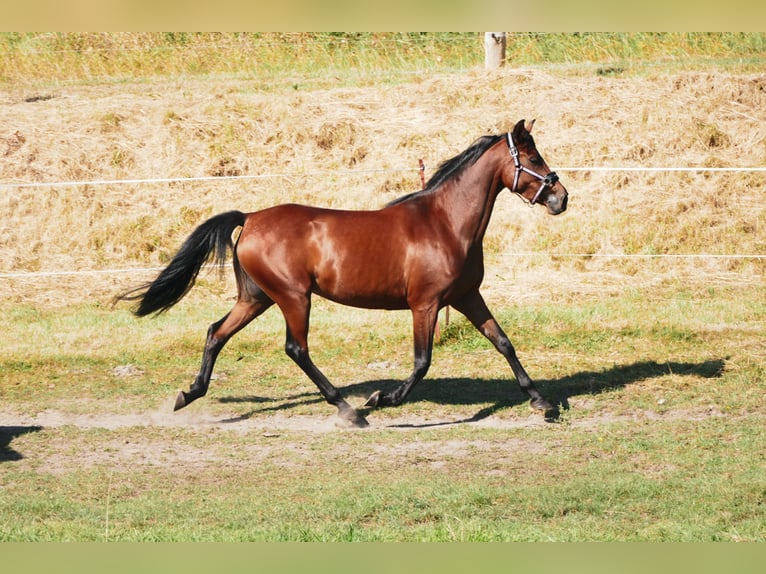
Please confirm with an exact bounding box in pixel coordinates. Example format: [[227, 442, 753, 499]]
[[438, 151, 502, 246]]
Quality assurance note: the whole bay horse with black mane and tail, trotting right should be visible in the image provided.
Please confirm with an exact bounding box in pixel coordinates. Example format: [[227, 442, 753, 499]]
[[117, 120, 567, 426]]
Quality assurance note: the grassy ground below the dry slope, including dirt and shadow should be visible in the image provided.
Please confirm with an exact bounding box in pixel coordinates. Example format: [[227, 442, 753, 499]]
[[0, 288, 766, 541]]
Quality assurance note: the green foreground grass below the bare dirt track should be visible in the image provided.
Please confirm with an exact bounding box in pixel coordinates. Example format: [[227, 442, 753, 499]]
[[0, 420, 766, 541]]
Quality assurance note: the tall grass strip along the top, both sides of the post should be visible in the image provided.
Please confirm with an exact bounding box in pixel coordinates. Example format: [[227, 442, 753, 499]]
[[0, 32, 766, 85]]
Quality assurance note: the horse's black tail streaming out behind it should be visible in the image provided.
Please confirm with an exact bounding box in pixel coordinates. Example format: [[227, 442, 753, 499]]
[[115, 211, 245, 317]]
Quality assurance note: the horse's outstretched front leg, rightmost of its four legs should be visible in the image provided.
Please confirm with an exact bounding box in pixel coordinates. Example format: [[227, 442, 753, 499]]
[[453, 291, 553, 412]]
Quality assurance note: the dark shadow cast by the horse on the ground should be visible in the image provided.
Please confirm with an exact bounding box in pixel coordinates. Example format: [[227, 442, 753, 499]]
[[219, 359, 725, 428]]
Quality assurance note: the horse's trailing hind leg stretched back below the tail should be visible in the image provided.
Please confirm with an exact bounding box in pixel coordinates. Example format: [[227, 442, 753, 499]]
[[173, 293, 274, 411]]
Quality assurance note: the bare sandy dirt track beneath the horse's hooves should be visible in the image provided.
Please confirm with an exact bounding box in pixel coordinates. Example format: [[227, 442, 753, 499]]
[[0, 402, 736, 474]]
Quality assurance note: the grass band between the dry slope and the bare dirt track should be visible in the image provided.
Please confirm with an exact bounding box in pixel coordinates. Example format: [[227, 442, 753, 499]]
[[0, 287, 766, 412]]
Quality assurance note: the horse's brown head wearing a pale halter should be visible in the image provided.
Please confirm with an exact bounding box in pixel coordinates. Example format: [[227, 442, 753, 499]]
[[502, 120, 567, 215]]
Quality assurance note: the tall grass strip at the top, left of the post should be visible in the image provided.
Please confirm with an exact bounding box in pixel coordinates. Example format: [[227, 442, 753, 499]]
[[0, 33, 481, 88]]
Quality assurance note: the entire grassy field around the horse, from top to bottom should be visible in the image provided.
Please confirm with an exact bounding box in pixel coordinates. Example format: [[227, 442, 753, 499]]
[[0, 34, 766, 542]]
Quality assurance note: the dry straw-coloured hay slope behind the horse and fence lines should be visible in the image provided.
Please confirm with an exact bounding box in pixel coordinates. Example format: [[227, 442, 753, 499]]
[[0, 69, 766, 302]]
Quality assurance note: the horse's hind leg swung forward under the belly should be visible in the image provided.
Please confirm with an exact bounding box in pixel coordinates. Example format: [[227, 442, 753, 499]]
[[282, 298, 368, 428]]
